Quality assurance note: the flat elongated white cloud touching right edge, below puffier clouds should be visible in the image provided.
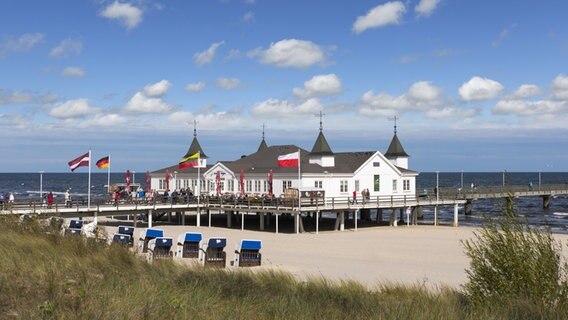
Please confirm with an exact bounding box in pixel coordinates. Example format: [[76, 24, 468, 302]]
[[492, 100, 568, 116]]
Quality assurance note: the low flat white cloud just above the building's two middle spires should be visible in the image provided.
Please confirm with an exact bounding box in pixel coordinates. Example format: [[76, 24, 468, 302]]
[[251, 98, 323, 118]]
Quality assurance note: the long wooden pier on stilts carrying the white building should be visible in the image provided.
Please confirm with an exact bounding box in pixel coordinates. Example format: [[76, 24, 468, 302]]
[[1, 184, 568, 233]]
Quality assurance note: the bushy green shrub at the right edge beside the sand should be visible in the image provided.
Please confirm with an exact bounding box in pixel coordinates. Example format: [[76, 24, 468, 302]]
[[463, 200, 568, 310]]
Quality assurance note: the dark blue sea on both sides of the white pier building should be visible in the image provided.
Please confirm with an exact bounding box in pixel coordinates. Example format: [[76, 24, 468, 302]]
[[0, 172, 568, 234]]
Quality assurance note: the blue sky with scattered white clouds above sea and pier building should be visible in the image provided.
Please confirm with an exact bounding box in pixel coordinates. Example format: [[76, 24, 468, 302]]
[[0, 0, 568, 172]]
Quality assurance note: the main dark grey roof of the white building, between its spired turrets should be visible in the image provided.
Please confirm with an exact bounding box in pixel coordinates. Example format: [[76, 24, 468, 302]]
[[220, 145, 375, 174]]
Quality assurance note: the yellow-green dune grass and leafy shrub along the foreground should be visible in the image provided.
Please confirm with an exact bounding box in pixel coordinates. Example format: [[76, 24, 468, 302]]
[[0, 209, 568, 319]]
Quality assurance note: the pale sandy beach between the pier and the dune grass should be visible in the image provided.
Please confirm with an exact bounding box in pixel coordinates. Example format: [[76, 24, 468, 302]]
[[101, 221, 568, 289]]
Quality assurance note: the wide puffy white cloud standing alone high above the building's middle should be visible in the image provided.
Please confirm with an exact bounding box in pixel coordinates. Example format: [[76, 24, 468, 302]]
[[249, 39, 325, 68]]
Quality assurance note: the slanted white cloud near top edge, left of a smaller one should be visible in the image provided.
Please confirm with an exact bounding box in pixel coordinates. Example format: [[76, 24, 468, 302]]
[[352, 1, 406, 33]]
